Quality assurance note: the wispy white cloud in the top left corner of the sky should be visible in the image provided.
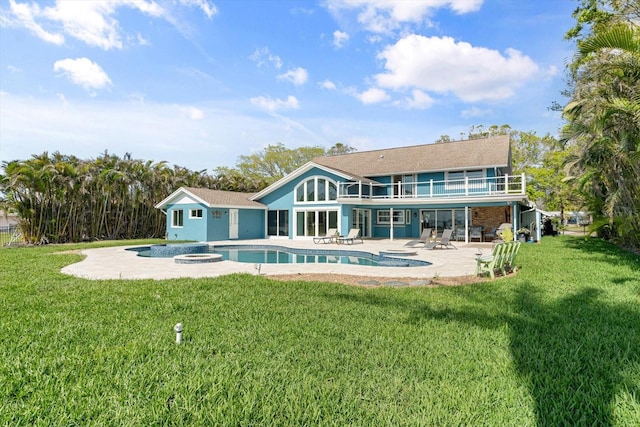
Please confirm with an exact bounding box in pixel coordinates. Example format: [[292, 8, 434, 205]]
[[2, 0, 217, 50]]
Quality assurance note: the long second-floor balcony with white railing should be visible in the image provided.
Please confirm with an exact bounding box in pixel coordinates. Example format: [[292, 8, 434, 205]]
[[338, 174, 526, 202]]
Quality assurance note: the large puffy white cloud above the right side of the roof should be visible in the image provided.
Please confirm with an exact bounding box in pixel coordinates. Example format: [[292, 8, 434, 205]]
[[375, 35, 539, 102]]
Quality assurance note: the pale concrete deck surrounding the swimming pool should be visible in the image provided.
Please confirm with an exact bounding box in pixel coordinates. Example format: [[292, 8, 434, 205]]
[[61, 239, 492, 280]]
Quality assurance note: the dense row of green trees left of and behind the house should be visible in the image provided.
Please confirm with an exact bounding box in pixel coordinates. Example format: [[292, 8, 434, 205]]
[[0, 144, 353, 244]]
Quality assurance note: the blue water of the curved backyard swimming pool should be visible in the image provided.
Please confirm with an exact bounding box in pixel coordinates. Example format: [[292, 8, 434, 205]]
[[132, 245, 431, 267]]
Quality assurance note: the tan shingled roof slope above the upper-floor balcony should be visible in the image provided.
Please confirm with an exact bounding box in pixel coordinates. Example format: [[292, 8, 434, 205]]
[[313, 135, 511, 177]]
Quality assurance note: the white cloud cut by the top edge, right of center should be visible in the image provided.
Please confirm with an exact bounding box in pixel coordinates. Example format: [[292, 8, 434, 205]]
[[327, 0, 484, 33]]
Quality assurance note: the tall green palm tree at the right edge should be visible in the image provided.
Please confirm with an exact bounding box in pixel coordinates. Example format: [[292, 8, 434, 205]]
[[563, 0, 640, 247]]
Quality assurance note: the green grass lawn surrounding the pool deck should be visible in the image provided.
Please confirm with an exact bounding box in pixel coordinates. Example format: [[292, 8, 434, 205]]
[[0, 236, 640, 426]]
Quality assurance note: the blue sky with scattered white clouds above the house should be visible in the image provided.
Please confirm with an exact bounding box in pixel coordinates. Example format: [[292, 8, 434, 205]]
[[0, 0, 577, 170]]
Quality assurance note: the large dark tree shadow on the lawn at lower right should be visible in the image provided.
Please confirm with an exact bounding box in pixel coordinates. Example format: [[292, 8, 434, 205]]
[[410, 285, 640, 426]]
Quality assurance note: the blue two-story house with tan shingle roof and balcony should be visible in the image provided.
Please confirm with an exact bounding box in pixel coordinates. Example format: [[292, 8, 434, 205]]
[[156, 136, 530, 241]]
